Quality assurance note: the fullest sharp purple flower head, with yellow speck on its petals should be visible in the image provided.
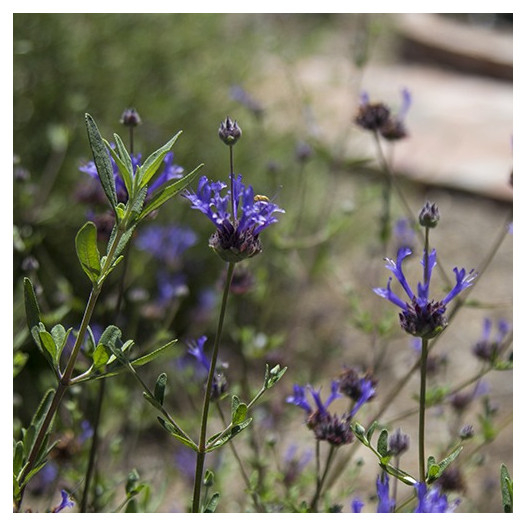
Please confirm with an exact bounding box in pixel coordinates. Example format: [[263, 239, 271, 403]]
[[183, 175, 284, 262]]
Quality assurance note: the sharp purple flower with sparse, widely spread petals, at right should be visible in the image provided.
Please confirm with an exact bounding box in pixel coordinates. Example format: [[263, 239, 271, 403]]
[[373, 248, 476, 339]]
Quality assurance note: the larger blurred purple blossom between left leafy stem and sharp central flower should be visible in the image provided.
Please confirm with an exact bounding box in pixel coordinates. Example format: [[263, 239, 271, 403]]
[[137, 225, 197, 268]]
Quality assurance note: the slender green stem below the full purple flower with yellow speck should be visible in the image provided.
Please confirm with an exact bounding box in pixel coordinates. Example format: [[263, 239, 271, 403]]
[[192, 263, 235, 513]]
